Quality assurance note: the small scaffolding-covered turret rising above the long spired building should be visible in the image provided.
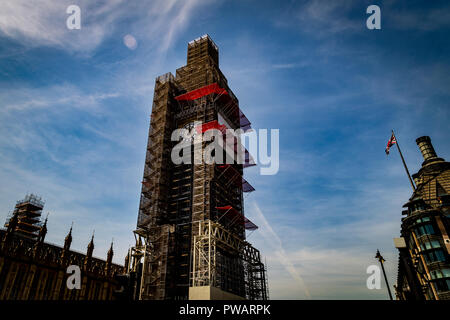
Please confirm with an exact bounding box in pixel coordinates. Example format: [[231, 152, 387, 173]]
[[5, 194, 44, 239]]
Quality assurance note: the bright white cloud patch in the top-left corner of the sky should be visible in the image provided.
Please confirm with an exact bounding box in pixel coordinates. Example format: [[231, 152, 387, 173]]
[[0, 0, 118, 51]]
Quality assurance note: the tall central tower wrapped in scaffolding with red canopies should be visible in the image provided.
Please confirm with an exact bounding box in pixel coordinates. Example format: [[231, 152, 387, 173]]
[[128, 35, 268, 299]]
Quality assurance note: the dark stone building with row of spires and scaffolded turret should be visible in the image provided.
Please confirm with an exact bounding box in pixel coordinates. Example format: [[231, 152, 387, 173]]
[[0, 195, 123, 300]]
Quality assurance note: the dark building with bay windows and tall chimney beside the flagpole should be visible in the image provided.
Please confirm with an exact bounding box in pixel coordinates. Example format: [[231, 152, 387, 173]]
[[396, 136, 450, 300]]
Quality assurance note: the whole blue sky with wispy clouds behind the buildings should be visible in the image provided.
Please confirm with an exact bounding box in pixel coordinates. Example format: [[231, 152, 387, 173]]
[[0, 0, 450, 299]]
